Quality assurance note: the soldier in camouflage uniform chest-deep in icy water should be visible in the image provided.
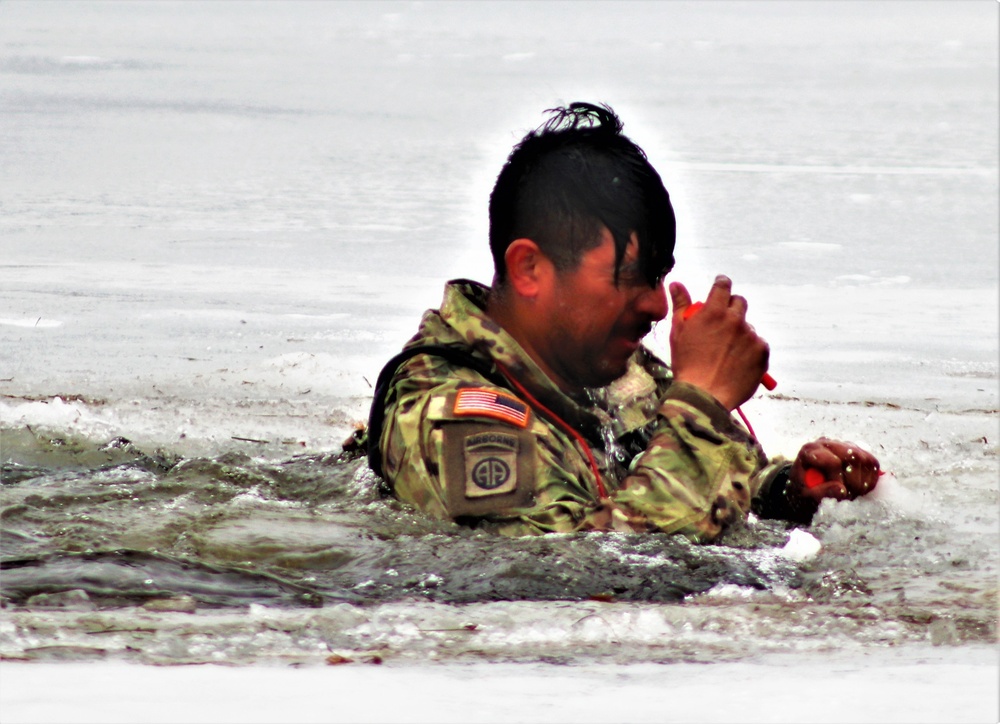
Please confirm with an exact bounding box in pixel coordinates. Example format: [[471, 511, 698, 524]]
[[368, 103, 879, 542]]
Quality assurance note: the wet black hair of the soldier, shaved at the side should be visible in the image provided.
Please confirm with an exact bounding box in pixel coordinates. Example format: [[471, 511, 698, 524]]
[[490, 103, 677, 285]]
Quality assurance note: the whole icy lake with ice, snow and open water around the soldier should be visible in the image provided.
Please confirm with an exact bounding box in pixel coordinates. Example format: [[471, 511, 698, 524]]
[[0, 2, 1000, 721]]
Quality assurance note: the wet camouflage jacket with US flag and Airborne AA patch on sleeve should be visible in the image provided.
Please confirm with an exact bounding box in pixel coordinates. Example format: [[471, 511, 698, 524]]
[[370, 280, 787, 541]]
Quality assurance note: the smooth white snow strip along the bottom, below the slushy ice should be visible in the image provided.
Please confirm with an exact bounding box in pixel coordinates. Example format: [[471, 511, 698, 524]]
[[0, 648, 998, 724]]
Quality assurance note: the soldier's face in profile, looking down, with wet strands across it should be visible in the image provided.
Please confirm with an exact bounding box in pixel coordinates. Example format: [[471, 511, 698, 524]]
[[538, 229, 667, 389]]
